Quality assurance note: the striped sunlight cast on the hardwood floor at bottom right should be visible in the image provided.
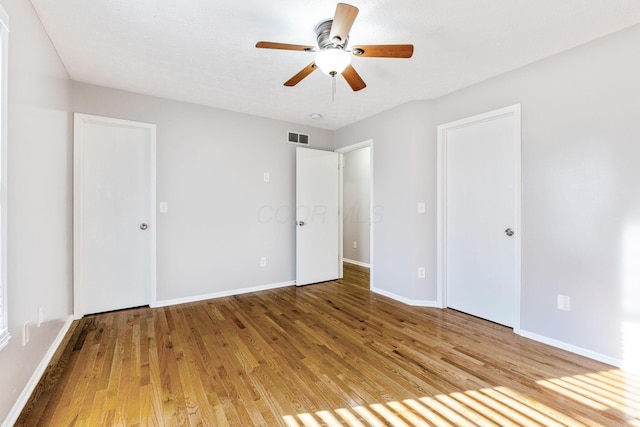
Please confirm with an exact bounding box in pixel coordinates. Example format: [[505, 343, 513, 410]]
[[283, 370, 640, 427]]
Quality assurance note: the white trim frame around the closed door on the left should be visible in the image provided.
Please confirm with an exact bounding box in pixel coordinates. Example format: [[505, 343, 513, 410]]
[[73, 113, 156, 319]]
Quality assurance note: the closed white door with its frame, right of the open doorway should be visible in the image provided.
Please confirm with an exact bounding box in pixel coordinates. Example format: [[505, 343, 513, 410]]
[[439, 106, 520, 327]]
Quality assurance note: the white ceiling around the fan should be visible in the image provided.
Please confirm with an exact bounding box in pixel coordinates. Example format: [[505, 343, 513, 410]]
[[31, 0, 640, 129]]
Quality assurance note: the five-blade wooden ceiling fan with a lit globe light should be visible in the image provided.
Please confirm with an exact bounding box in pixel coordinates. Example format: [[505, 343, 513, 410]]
[[256, 3, 413, 91]]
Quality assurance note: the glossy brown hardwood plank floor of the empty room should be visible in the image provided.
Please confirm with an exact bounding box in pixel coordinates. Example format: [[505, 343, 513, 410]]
[[16, 265, 640, 426]]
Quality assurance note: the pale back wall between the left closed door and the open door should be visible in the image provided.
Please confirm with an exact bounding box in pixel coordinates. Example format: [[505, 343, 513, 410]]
[[73, 83, 332, 303]]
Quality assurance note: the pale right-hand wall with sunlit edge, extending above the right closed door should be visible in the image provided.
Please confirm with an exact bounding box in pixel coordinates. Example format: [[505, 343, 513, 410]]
[[437, 26, 640, 363]]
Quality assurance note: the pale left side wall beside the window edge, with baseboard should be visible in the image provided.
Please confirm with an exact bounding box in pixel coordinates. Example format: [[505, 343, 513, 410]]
[[0, 0, 72, 421]]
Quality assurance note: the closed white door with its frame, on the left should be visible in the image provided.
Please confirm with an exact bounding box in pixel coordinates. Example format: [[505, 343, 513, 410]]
[[74, 114, 156, 317]]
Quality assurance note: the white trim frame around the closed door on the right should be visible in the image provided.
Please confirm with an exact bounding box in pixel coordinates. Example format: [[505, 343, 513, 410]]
[[436, 104, 522, 334]]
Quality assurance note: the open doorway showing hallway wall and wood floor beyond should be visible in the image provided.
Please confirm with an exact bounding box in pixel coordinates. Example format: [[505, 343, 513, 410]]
[[336, 140, 373, 289]]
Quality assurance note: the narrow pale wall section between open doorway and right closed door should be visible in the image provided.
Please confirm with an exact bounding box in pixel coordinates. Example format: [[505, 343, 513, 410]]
[[334, 102, 436, 305]]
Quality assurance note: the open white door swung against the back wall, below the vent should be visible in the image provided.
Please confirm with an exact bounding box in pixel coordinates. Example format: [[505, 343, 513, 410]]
[[296, 147, 340, 286]]
